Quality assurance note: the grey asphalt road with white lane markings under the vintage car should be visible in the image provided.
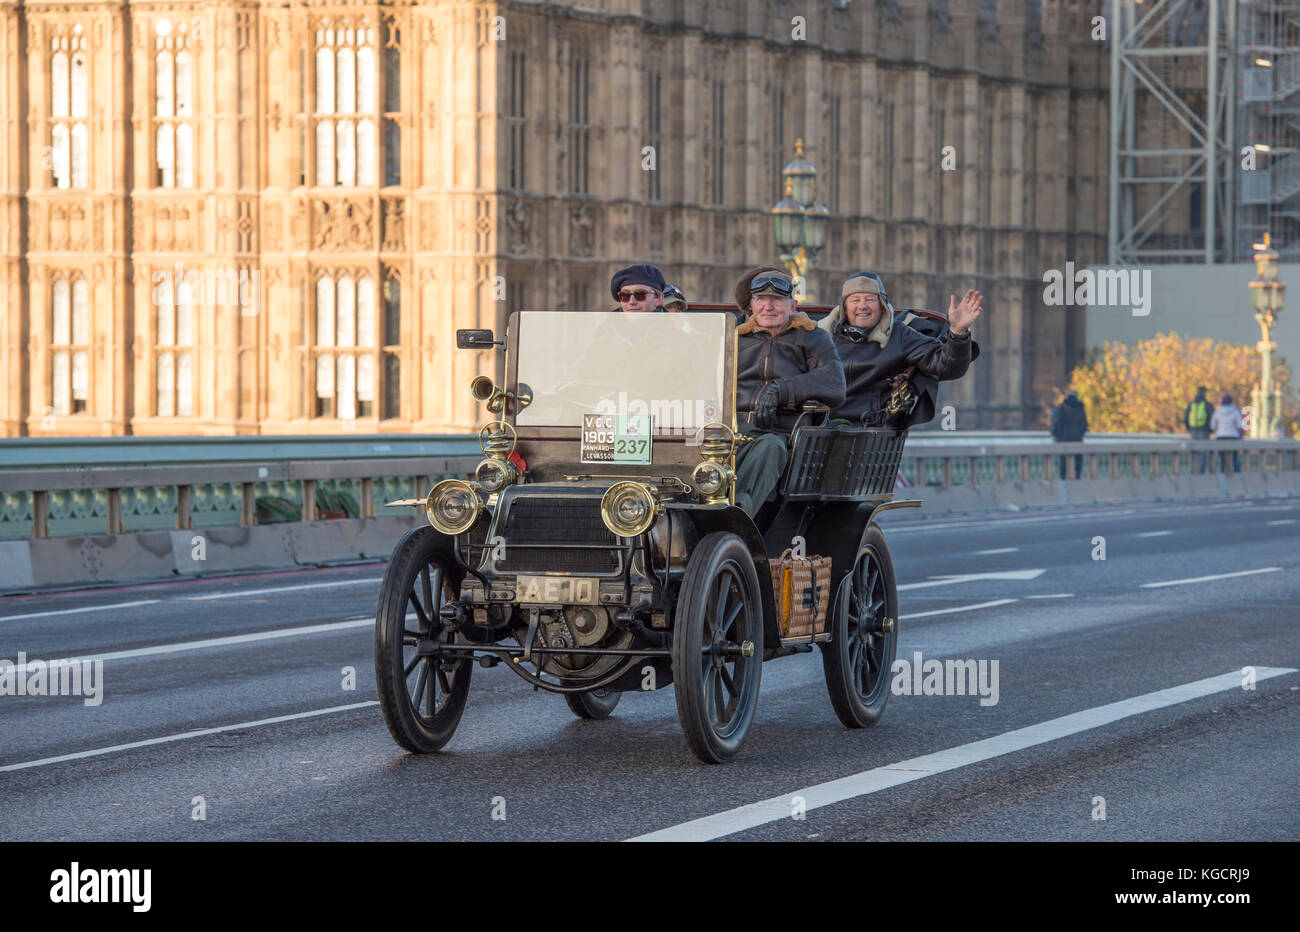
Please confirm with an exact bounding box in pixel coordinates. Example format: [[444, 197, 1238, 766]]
[[0, 499, 1300, 841]]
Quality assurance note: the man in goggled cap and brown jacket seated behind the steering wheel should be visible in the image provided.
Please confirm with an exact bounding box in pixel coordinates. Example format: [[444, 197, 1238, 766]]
[[736, 266, 844, 517]]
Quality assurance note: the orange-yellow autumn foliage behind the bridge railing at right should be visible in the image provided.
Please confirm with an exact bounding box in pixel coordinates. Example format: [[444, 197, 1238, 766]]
[[1053, 333, 1300, 437]]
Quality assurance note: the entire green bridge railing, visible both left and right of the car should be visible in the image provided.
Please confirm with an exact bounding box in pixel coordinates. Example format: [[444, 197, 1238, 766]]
[[0, 432, 1300, 541]]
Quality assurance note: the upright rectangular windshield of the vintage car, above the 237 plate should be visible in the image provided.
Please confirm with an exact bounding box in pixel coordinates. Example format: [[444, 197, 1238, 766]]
[[515, 311, 732, 434]]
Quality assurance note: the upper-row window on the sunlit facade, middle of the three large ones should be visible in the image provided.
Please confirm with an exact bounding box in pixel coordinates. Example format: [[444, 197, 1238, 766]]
[[153, 19, 194, 187]]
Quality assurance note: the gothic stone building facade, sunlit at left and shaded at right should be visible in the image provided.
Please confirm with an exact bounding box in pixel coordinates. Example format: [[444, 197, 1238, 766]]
[[0, 0, 1108, 435]]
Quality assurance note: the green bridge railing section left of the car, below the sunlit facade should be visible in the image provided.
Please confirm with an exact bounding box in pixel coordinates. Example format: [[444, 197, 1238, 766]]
[[0, 435, 481, 539]]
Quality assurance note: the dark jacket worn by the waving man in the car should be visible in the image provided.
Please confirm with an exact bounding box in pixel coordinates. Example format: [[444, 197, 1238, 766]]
[[831, 313, 971, 424]]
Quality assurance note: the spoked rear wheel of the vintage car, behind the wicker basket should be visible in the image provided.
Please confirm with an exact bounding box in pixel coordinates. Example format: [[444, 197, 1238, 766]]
[[822, 524, 898, 728]]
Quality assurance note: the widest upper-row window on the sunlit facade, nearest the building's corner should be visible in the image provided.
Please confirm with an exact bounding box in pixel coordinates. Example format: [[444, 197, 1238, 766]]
[[315, 23, 387, 187]]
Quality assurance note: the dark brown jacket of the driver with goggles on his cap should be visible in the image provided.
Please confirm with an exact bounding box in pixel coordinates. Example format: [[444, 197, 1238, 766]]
[[736, 311, 844, 433]]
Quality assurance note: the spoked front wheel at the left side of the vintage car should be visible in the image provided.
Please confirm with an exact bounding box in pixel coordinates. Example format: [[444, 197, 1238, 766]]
[[374, 528, 473, 754]]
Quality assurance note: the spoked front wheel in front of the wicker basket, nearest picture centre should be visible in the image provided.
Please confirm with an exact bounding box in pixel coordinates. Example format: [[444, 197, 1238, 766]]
[[672, 532, 763, 764]]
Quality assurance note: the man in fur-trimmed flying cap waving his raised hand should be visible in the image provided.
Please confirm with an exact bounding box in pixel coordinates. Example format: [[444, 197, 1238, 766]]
[[818, 272, 984, 428]]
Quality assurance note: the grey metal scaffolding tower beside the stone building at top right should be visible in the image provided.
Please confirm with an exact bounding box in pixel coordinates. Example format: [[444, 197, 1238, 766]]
[[1109, 0, 1300, 265]]
